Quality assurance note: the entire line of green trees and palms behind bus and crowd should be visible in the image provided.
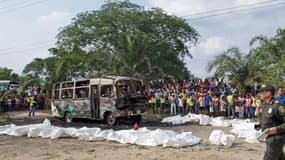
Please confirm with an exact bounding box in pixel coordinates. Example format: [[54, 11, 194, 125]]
[[0, 1, 285, 93]]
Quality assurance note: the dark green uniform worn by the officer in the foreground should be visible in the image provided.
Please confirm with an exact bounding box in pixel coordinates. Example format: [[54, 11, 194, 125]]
[[260, 100, 285, 160]]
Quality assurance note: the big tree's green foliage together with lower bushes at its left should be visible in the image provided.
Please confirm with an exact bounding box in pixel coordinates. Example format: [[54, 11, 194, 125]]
[[23, 1, 199, 92]]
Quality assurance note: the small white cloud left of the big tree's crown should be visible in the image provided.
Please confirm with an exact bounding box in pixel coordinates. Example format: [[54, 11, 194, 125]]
[[37, 11, 73, 25]]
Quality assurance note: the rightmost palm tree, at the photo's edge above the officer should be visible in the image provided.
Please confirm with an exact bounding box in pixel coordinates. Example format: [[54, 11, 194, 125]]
[[248, 29, 285, 85]]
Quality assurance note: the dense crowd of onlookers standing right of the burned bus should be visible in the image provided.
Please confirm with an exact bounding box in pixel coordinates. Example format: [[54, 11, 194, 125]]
[[146, 78, 285, 119]]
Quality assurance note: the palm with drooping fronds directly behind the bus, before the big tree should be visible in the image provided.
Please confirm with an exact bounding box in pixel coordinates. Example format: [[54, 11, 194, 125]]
[[113, 33, 151, 78]]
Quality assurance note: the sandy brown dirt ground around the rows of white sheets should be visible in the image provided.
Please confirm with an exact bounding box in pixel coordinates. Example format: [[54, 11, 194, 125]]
[[0, 112, 265, 160]]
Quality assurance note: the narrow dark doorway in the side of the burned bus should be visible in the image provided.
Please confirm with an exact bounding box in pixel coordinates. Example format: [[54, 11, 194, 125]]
[[91, 85, 100, 119]]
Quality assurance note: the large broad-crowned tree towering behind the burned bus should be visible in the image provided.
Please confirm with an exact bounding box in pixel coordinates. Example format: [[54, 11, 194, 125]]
[[54, 1, 198, 78]]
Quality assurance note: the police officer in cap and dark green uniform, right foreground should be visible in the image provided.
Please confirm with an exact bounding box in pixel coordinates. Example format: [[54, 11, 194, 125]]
[[260, 85, 285, 160]]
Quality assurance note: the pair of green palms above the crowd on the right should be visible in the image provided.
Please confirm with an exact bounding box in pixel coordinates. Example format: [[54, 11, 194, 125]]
[[208, 29, 285, 90]]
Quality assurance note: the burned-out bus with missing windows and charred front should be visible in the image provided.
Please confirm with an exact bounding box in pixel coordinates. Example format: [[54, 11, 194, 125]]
[[51, 76, 146, 126]]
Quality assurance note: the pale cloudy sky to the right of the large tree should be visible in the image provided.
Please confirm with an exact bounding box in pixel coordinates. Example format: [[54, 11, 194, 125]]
[[147, 0, 285, 77]]
